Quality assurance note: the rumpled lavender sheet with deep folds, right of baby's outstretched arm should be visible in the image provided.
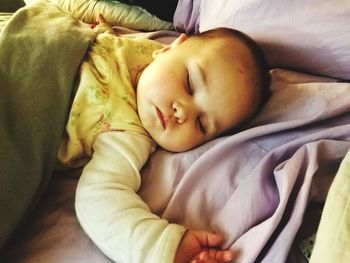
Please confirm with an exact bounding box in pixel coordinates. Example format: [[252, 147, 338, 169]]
[[141, 70, 350, 263]]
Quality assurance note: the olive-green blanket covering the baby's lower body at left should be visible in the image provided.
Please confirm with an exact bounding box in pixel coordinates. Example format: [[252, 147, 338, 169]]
[[0, 1, 94, 251]]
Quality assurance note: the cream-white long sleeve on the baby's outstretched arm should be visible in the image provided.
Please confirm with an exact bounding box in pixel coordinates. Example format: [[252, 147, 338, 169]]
[[75, 132, 185, 263]]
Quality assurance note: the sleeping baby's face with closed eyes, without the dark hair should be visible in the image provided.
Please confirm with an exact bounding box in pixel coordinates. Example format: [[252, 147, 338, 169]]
[[137, 35, 258, 152]]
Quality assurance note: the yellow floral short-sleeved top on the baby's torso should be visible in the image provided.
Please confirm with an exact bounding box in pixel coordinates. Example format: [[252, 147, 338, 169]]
[[58, 33, 161, 167]]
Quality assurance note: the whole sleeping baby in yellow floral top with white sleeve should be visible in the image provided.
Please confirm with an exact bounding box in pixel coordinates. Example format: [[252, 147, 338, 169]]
[[58, 16, 269, 263]]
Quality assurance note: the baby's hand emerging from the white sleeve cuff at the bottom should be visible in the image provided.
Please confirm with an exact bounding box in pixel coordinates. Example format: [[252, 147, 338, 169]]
[[175, 230, 237, 263]]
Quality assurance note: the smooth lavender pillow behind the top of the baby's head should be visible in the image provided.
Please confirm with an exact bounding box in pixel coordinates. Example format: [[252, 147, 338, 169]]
[[173, 0, 350, 80]]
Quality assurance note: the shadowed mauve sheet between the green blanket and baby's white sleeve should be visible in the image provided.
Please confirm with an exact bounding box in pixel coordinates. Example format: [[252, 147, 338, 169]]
[[1, 170, 112, 263]]
